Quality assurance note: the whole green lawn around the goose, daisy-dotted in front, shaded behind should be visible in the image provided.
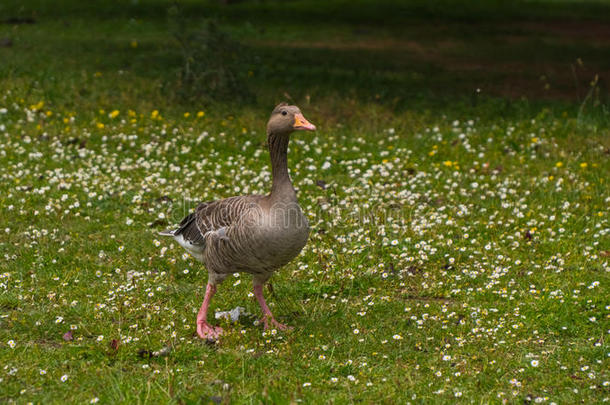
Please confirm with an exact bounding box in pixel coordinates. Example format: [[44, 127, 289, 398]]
[[0, 1, 610, 403]]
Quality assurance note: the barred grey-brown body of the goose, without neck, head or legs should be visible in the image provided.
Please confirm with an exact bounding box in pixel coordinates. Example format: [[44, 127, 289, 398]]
[[166, 195, 309, 283]]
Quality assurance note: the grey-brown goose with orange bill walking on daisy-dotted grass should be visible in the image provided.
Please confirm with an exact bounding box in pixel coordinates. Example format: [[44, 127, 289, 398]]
[[159, 103, 316, 340]]
